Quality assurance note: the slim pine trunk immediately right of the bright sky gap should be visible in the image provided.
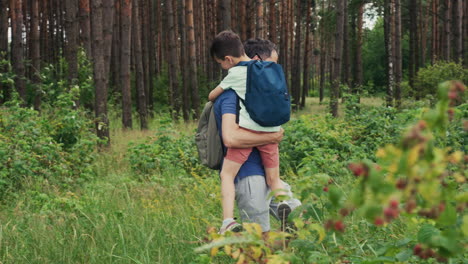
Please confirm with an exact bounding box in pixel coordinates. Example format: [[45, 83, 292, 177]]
[[384, 0, 395, 106]]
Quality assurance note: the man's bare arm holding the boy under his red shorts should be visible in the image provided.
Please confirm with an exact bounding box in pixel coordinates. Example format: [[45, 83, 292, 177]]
[[222, 114, 284, 148]]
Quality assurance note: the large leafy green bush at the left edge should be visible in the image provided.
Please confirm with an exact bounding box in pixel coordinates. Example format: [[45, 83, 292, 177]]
[[0, 89, 97, 197]]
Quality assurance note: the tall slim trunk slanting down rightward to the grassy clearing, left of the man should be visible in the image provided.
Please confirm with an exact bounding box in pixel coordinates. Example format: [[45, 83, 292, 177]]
[[132, 1, 147, 130]]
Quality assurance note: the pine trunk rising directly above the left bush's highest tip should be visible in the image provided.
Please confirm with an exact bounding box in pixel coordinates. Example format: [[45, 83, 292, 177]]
[[65, 0, 79, 84]]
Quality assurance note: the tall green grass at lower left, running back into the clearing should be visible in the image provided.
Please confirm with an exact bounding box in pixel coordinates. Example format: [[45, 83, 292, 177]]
[[0, 98, 390, 264]]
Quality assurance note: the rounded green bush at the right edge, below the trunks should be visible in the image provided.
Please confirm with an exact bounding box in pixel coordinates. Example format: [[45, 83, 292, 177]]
[[414, 61, 468, 97]]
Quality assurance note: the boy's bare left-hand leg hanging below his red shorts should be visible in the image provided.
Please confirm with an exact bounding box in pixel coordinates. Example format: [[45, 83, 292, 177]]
[[220, 159, 242, 219]]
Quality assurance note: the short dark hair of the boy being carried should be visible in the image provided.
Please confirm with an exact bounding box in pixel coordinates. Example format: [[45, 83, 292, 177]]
[[210, 30, 245, 60]]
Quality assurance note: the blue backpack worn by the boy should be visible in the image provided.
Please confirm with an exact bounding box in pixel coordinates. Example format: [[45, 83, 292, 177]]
[[237, 60, 291, 127]]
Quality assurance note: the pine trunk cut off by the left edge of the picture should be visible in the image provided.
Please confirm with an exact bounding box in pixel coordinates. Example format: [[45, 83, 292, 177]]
[[0, 0, 10, 105]]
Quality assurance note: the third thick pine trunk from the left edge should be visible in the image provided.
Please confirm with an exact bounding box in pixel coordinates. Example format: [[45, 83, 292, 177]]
[[30, 0, 41, 110]]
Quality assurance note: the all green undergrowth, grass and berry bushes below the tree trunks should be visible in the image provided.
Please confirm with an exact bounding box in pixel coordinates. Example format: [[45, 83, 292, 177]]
[[0, 81, 468, 263]]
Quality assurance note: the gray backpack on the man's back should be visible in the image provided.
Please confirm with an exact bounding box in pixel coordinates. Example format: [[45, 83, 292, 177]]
[[195, 102, 224, 170]]
